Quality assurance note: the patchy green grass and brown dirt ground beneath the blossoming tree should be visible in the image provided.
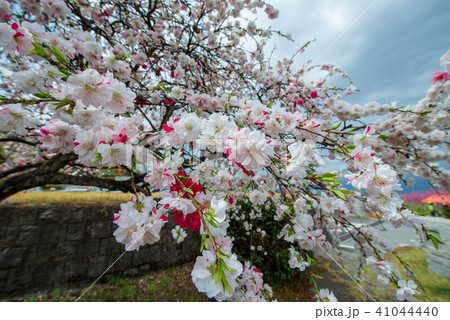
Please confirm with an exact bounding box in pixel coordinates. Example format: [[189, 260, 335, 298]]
[[1, 247, 450, 302]]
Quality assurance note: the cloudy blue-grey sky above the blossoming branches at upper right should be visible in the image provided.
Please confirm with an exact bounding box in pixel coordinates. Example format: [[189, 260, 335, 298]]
[[258, 0, 450, 105]]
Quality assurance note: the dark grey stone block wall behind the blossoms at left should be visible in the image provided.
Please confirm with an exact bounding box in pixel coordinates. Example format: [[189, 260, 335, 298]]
[[0, 205, 200, 297]]
